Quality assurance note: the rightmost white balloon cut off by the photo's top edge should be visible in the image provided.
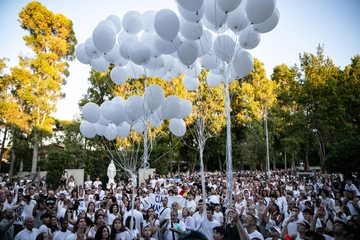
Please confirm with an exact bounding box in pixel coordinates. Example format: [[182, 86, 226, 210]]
[[245, 0, 276, 24]]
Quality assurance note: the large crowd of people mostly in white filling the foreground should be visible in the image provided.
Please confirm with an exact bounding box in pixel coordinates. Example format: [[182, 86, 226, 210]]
[[0, 170, 360, 240]]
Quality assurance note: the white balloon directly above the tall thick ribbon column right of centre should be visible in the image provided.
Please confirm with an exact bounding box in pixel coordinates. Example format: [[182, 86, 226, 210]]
[[214, 35, 235, 62]]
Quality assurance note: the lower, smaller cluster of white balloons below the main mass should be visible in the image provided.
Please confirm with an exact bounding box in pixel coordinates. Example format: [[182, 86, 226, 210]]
[[80, 84, 192, 141]]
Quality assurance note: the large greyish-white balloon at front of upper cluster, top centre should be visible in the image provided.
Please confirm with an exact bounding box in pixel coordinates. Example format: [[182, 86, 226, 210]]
[[154, 9, 180, 41]]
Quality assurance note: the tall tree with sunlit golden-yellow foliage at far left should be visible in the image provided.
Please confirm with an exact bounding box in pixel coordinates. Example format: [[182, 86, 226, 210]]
[[11, 2, 77, 172]]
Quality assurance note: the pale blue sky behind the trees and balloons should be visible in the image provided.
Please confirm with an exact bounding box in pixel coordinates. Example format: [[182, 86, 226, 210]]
[[0, 0, 360, 120]]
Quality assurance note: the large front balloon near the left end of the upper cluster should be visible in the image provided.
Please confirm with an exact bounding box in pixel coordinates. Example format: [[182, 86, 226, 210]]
[[92, 21, 116, 53]]
